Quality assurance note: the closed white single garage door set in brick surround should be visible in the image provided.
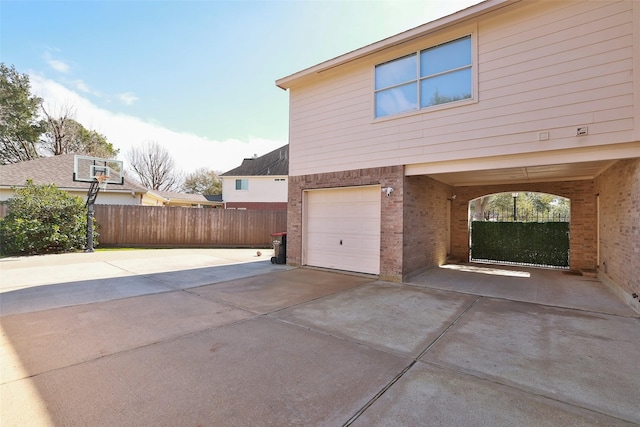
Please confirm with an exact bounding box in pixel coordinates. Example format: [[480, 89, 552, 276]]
[[304, 186, 381, 274]]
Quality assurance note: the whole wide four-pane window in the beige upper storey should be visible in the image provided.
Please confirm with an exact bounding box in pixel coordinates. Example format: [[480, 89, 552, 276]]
[[375, 35, 473, 117]]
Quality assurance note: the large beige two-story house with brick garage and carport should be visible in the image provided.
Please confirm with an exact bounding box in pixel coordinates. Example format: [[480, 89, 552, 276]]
[[276, 0, 640, 308]]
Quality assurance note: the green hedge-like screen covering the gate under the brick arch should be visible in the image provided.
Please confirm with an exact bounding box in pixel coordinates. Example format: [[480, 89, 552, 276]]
[[471, 221, 569, 267]]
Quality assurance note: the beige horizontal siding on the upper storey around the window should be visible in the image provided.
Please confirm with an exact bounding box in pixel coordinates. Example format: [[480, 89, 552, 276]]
[[290, 1, 640, 176]]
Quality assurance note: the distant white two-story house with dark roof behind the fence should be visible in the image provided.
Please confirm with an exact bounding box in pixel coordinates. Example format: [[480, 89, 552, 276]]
[[220, 145, 289, 210]]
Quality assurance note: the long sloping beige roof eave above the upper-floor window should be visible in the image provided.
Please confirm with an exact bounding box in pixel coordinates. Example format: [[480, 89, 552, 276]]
[[276, 0, 522, 90]]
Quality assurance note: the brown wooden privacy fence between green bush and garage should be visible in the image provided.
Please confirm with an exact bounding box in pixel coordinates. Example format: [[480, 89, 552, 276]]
[[95, 205, 287, 247]]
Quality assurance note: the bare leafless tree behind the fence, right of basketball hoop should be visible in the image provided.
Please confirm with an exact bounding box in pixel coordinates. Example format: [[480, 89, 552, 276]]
[[127, 141, 182, 191]]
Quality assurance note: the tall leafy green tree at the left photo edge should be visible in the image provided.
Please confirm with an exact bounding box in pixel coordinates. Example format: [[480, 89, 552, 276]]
[[0, 63, 45, 165]]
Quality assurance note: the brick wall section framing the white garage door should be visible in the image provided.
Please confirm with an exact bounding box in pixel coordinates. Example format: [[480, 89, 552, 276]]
[[287, 166, 404, 280]]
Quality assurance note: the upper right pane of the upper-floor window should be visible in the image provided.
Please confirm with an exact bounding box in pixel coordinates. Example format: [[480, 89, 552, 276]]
[[420, 36, 471, 77]]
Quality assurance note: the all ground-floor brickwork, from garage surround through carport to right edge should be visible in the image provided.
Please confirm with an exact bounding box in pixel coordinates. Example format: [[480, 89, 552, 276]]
[[287, 166, 640, 291]]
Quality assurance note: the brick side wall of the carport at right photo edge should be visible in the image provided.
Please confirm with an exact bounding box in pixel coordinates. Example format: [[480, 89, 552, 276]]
[[595, 159, 640, 310]]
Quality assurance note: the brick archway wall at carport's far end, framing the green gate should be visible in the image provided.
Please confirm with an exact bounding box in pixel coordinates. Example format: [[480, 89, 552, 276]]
[[451, 180, 597, 270]]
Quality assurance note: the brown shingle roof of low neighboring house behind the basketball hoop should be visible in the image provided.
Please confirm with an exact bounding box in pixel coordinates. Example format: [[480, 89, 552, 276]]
[[0, 154, 147, 193]]
